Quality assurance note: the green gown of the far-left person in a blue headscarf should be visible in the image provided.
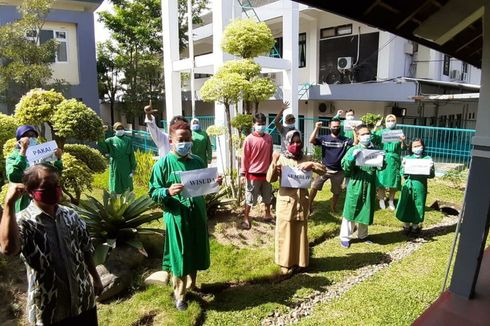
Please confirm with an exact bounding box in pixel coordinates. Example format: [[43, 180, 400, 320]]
[[5, 148, 63, 213]]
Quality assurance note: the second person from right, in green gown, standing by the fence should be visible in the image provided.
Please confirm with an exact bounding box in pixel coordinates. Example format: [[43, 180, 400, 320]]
[[376, 114, 405, 211]]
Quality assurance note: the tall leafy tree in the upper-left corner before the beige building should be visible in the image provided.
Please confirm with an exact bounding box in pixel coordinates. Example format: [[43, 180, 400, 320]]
[[0, 0, 65, 112]]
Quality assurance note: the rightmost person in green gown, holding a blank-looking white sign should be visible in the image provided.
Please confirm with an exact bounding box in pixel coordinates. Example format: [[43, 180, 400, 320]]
[[395, 138, 435, 235]]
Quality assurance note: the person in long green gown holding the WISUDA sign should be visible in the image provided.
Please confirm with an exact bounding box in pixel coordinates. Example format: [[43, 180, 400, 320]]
[[149, 121, 221, 310]]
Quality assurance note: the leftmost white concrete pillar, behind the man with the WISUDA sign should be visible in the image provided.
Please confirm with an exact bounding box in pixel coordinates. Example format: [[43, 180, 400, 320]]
[[162, 0, 182, 123]]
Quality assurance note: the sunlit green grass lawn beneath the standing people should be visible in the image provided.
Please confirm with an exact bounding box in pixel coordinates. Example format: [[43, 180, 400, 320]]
[[92, 176, 463, 325]]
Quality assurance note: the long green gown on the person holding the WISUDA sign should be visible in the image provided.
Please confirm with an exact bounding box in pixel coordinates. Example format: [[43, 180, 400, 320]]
[[149, 152, 210, 278]]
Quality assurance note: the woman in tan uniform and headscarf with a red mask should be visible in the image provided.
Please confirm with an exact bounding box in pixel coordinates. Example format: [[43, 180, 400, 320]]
[[267, 130, 325, 274]]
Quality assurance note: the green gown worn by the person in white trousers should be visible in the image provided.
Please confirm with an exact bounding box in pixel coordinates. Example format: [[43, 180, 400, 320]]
[[342, 144, 385, 225]]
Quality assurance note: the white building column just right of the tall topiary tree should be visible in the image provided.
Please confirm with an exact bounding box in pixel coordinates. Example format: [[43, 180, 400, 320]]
[[282, 0, 299, 128]]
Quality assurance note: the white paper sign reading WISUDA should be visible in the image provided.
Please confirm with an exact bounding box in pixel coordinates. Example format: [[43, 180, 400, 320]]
[[179, 168, 219, 197]]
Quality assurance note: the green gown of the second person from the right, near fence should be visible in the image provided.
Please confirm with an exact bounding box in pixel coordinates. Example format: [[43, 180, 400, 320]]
[[374, 129, 402, 190]]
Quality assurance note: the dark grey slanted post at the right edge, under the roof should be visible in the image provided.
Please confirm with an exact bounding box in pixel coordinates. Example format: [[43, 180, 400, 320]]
[[450, 0, 490, 299]]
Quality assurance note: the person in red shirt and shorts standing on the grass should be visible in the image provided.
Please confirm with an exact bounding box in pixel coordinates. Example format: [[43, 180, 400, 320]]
[[240, 113, 274, 230]]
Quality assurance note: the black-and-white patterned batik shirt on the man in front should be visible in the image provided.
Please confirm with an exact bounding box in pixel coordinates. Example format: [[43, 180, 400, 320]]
[[17, 202, 95, 325]]
